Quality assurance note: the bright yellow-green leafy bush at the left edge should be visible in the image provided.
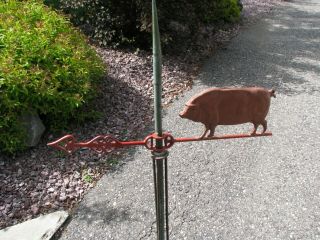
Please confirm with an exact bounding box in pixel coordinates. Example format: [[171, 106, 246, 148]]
[[0, 0, 105, 153]]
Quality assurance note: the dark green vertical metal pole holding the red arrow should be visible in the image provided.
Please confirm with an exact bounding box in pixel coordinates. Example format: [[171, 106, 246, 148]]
[[152, 0, 169, 240]]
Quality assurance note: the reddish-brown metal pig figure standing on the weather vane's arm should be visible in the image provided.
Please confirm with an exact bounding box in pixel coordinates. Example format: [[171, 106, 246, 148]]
[[179, 87, 276, 138]]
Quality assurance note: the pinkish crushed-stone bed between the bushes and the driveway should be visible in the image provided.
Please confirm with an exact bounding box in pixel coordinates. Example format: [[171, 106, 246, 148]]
[[0, 0, 278, 229]]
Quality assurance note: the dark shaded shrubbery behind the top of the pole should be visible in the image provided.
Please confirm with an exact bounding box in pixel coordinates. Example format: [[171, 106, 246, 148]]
[[45, 0, 241, 48]]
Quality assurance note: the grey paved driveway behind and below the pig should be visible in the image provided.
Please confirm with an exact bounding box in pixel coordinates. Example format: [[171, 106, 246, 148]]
[[61, 0, 320, 240]]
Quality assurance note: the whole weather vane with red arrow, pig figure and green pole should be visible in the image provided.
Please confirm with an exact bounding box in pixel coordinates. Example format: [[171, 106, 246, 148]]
[[48, 0, 275, 240]]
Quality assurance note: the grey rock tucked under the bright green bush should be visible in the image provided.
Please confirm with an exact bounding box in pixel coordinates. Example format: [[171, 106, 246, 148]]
[[20, 111, 45, 147]]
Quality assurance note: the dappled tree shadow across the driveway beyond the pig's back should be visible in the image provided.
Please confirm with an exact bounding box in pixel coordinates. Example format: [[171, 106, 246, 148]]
[[201, 0, 320, 95]]
